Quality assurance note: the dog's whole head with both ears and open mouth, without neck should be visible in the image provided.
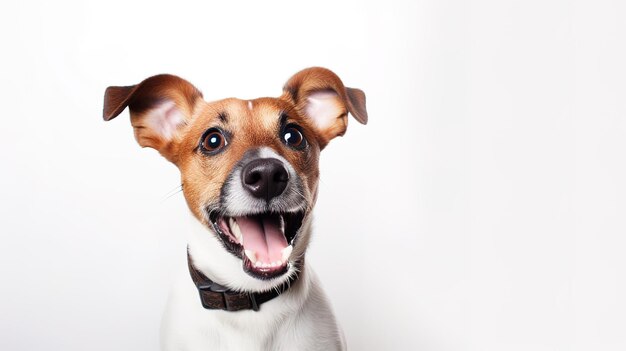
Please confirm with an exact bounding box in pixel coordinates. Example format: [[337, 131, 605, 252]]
[[104, 67, 367, 290]]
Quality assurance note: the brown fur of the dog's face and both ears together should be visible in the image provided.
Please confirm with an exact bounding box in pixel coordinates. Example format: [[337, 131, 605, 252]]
[[103, 67, 367, 222]]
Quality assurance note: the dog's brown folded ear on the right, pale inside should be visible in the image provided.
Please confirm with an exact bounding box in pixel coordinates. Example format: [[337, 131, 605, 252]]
[[281, 67, 367, 148]]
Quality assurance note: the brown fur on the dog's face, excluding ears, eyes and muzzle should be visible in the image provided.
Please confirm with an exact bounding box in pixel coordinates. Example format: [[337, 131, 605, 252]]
[[175, 98, 319, 220]]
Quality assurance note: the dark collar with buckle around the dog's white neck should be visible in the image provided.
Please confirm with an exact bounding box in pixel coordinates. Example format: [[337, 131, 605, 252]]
[[187, 252, 298, 312]]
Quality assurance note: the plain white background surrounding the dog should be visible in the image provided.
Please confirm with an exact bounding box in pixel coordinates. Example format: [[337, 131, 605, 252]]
[[0, 0, 626, 351]]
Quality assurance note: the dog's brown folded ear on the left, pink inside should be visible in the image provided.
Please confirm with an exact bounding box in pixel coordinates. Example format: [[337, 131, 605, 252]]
[[103, 74, 202, 162]]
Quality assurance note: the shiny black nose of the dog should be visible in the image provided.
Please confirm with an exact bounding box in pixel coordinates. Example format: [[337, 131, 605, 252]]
[[241, 158, 289, 201]]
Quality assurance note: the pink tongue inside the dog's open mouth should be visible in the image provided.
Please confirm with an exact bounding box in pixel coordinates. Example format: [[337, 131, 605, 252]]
[[235, 216, 288, 263]]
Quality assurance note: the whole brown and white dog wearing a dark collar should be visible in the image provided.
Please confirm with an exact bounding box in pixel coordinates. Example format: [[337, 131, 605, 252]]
[[103, 67, 368, 350]]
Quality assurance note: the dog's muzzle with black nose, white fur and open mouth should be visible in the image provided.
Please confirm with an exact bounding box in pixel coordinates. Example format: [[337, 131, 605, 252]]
[[207, 154, 307, 279]]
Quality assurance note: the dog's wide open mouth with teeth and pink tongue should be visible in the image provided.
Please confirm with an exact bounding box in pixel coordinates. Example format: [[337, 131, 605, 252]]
[[209, 212, 304, 279]]
